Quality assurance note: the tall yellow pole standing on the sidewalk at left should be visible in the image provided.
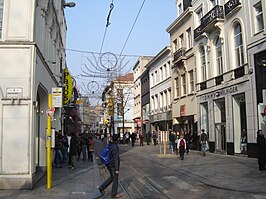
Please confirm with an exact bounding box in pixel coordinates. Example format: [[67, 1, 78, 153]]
[[46, 94, 52, 189]]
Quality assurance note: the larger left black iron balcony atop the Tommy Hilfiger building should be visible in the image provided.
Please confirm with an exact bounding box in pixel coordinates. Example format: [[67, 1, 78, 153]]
[[194, 5, 224, 39]]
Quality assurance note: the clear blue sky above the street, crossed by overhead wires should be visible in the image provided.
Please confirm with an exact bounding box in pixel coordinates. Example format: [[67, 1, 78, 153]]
[[65, 0, 176, 102]]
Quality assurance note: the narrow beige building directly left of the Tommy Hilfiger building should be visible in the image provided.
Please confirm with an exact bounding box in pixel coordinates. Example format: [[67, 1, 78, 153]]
[[167, 0, 198, 144]]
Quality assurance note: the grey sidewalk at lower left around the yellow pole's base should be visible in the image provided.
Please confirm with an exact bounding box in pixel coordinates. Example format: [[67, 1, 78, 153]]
[[0, 160, 102, 199]]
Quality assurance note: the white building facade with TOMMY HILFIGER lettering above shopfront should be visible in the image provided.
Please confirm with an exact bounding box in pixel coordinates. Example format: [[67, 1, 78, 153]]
[[192, 0, 265, 157]]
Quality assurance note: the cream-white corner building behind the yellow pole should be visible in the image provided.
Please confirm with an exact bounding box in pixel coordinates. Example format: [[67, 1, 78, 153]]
[[0, 0, 66, 189]]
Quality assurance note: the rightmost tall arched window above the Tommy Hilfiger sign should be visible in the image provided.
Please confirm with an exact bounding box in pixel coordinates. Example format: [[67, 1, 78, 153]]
[[234, 23, 244, 67]]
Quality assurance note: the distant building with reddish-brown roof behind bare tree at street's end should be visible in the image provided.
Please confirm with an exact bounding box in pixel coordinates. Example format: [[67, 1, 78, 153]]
[[102, 73, 134, 138]]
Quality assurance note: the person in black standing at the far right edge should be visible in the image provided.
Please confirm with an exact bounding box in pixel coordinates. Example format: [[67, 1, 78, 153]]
[[257, 130, 266, 171]]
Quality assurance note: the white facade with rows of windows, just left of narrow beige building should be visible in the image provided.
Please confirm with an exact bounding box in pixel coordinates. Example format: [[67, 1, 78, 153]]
[[147, 46, 172, 140]]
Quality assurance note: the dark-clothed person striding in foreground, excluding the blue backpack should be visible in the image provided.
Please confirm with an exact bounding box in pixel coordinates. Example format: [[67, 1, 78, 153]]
[[99, 134, 120, 198]]
